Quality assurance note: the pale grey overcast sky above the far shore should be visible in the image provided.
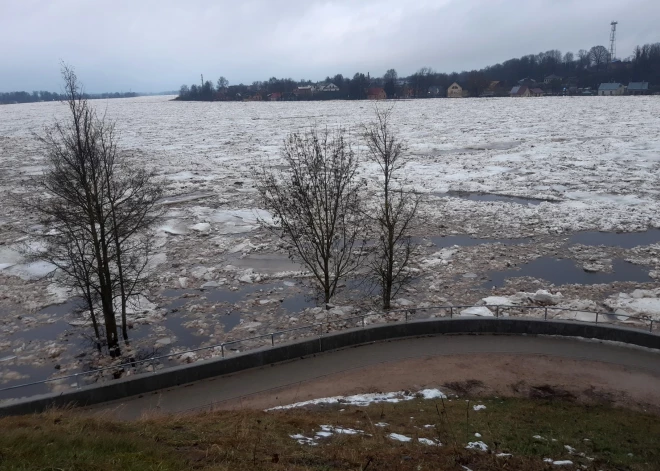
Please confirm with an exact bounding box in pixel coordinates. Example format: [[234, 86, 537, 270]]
[[0, 0, 660, 92]]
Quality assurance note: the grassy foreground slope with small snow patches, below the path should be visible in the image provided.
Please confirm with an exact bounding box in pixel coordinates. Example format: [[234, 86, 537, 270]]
[[0, 399, 660, 471]]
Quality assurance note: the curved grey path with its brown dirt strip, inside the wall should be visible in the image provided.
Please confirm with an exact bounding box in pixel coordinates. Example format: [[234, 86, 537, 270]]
[[89, 335, 660, 420]]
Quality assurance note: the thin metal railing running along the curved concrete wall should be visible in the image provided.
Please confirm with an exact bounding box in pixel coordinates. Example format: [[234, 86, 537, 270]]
[[0, 305, 660, 402]]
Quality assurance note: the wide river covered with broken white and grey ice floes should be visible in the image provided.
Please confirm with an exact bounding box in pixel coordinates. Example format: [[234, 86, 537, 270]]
[[0, 97, 660, 394]]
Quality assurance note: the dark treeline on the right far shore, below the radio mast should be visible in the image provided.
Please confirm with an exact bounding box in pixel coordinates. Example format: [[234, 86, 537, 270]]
[[178, 43, 660, 101]]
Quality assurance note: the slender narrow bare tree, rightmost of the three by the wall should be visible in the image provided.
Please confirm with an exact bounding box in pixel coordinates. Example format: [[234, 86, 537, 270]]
[[364, 108, 420, 309]]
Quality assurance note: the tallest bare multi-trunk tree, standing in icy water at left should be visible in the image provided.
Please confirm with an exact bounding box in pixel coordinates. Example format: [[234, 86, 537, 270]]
[[23, 66, 162, 356]]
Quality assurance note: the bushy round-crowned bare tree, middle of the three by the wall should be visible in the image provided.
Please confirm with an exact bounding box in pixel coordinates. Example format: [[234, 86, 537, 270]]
[[258, 129, 365, 303]]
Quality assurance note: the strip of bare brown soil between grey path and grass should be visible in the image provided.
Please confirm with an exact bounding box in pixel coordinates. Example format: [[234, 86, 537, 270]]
[[213, 354, 660, 414]]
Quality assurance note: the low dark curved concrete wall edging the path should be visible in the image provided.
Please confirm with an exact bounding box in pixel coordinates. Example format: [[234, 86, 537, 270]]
[[0, 318, 660, 416]]
